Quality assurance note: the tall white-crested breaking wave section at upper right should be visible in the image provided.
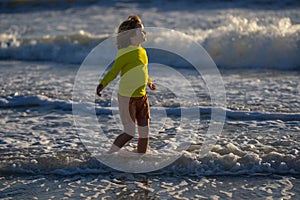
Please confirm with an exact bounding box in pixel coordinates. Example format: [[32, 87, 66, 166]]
[[202, 15, 300, 69]]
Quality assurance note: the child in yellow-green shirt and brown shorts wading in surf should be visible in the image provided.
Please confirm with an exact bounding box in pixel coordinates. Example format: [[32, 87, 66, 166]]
[[97, 16, 156, 153]]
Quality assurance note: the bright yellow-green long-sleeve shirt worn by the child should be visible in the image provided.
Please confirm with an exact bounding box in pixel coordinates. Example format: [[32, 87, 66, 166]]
[[100, 46, 151, 97]]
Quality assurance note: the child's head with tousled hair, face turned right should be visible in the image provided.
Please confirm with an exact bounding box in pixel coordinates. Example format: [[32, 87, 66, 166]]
[[117, 15, 146, 49]]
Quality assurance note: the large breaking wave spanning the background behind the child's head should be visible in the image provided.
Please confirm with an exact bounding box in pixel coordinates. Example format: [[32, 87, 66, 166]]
[[0, 15, 300, 69]]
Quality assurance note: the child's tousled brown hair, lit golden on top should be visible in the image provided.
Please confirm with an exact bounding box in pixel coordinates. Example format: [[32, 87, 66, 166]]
[[117, 15, 142, 49]]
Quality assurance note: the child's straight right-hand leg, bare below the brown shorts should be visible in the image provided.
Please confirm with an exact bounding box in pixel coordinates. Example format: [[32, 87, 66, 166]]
[[137, 119, 149, 153]]
